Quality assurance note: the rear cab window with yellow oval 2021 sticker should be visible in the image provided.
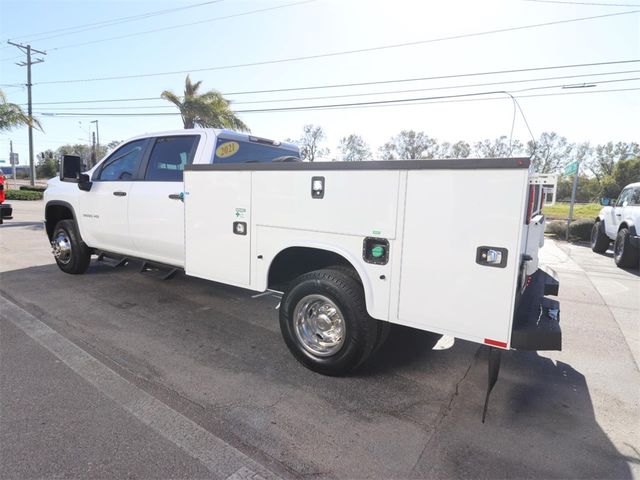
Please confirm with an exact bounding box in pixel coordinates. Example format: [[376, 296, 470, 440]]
[[211, 132, 300, 163]]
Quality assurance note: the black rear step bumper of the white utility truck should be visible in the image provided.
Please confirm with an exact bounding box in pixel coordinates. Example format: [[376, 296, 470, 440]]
[[511, 269, 562, 350]]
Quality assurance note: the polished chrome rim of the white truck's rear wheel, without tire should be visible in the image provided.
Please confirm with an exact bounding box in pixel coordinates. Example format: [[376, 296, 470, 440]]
[[293, 295, 347, 357]]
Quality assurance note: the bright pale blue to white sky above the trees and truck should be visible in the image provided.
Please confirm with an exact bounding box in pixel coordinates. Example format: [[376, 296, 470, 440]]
[[0, 0, 640, 166]]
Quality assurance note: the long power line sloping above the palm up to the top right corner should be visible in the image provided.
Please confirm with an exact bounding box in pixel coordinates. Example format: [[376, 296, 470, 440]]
[[40, 10, 640, 84]]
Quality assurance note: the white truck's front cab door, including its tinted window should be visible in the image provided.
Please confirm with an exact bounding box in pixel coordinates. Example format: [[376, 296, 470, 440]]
[[77, 139, 148, 255]]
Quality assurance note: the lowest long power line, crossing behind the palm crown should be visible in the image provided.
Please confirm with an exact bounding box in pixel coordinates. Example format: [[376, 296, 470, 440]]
[[33, 87, 640, 117]]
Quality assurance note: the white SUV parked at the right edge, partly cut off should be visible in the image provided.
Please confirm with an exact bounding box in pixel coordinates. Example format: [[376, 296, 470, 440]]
[[591, 182, 640, 268]]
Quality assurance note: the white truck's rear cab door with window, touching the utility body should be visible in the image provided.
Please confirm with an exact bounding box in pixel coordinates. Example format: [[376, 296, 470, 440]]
[[128, 134, 205, 267]]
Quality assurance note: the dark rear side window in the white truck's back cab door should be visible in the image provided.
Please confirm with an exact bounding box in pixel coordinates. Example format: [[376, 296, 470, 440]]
[[144, 135, 200, 182]]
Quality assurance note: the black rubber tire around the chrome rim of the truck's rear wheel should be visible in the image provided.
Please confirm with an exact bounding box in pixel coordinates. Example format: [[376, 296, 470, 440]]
[[280, 269, 378, 376]]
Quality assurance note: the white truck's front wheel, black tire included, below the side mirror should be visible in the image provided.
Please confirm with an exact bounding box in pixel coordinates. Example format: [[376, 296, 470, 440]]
[[51, 220, 91, 274]]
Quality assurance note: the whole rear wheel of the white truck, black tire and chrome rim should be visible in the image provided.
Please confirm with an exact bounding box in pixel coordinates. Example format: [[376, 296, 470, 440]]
[[280, 269, 377, 375]]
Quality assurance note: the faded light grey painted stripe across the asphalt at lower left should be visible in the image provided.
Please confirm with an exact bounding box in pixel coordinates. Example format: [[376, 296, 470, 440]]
[[0, 296, 280, 480]]
